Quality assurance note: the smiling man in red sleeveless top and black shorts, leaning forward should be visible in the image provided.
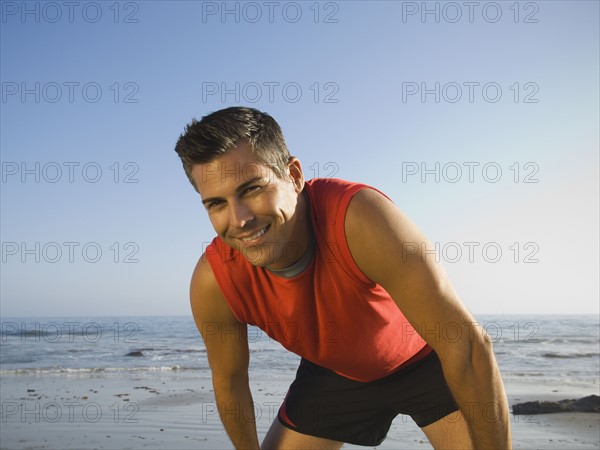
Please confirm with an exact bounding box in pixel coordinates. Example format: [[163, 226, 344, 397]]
[[176, 107, 511, 449]]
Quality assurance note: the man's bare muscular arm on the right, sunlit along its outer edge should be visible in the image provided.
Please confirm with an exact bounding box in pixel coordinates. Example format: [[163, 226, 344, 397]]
[[345, 189, 511, 449]]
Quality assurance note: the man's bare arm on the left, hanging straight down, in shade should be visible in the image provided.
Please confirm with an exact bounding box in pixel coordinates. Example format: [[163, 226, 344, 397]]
[[190, 255, 259, 450]]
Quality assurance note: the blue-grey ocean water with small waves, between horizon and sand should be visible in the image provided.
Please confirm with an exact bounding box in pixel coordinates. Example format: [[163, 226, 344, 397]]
[[0, 315, 600, 393]]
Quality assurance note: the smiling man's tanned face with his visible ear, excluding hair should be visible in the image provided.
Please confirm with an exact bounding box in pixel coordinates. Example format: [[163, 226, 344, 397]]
[[192, 143, 308, 269]]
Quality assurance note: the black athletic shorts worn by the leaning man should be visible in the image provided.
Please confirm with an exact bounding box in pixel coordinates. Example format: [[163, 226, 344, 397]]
[[278, 350, 458, 446]]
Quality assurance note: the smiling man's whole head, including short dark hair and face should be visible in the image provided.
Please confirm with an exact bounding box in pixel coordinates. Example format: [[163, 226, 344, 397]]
[[176, 108, 309, 269]]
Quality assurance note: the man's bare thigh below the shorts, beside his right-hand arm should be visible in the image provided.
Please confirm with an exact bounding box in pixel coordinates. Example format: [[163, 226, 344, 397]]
[[421, 411, 473, 450]]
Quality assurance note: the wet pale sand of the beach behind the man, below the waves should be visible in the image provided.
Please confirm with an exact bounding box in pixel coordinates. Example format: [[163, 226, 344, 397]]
[[0, 371, 600, 450]]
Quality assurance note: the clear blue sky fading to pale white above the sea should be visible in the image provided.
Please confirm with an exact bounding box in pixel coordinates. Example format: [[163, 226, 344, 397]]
[[0, 0, 599, 317]]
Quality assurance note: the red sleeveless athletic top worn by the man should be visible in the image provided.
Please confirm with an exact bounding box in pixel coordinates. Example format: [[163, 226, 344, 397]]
[[206, 179, 431, 381]]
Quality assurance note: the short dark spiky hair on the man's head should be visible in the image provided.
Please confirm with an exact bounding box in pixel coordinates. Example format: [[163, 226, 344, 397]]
[[175, 107, 290, 191]]
